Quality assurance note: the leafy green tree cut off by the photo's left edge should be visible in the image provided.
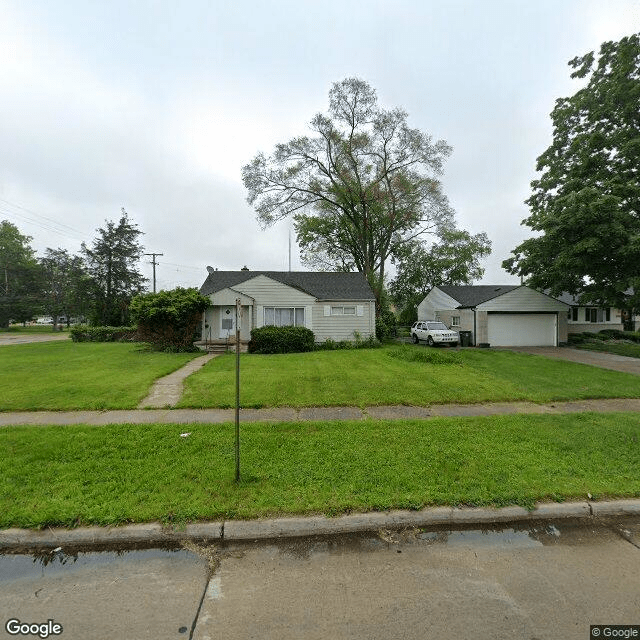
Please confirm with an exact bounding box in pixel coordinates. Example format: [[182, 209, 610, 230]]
[[0, 220, 40, 327]]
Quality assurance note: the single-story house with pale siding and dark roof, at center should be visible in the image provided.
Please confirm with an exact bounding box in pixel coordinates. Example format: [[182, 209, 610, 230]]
[[200, 267, 375, 350]]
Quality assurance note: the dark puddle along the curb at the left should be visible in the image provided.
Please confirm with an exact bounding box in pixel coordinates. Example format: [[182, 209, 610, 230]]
[[0, 549, 202, 582]]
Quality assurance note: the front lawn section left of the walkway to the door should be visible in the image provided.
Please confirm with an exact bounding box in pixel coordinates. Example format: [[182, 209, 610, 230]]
[[0, 340, 198, 411]]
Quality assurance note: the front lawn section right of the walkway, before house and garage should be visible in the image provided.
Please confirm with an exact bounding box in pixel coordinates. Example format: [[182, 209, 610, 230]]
[[179, 345, 640, 407]]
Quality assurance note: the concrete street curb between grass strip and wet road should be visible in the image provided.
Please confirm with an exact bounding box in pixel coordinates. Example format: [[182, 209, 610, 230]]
[[0, 499, 640, 551]]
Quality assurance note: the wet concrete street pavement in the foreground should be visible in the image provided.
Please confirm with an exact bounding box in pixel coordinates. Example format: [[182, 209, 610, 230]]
[[0, 518, 640, 640]]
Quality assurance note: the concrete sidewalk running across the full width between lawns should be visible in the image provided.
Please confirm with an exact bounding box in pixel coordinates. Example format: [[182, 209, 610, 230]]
[[0, 398, 640, 427]]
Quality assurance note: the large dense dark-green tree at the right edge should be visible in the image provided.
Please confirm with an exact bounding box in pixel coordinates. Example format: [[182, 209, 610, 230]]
[[503, 34, 640, 308]]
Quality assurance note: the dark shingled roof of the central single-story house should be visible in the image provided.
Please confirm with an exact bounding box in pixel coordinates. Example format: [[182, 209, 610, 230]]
[[200, 271, 375, 300]]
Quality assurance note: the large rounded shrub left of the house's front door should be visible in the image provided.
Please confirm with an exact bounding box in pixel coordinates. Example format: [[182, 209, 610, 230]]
[[129, 287, 211, 352]]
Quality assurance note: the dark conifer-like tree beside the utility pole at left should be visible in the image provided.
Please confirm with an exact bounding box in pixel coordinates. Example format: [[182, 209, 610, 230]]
[[82, 209, 146, 326]]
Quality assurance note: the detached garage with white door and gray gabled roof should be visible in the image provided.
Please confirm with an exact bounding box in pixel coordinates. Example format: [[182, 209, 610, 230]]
[[418, 285, 569, 347]]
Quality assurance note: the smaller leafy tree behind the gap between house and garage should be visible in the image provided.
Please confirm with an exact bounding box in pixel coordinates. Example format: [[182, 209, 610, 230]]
[[389, 229, 491, 322]]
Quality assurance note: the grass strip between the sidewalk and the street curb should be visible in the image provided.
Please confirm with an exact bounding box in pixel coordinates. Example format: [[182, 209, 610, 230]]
[[0, 413, 640, 528]]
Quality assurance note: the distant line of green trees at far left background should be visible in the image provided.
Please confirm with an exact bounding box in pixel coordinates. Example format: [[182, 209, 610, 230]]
[[0, 209, 146, 328]]
